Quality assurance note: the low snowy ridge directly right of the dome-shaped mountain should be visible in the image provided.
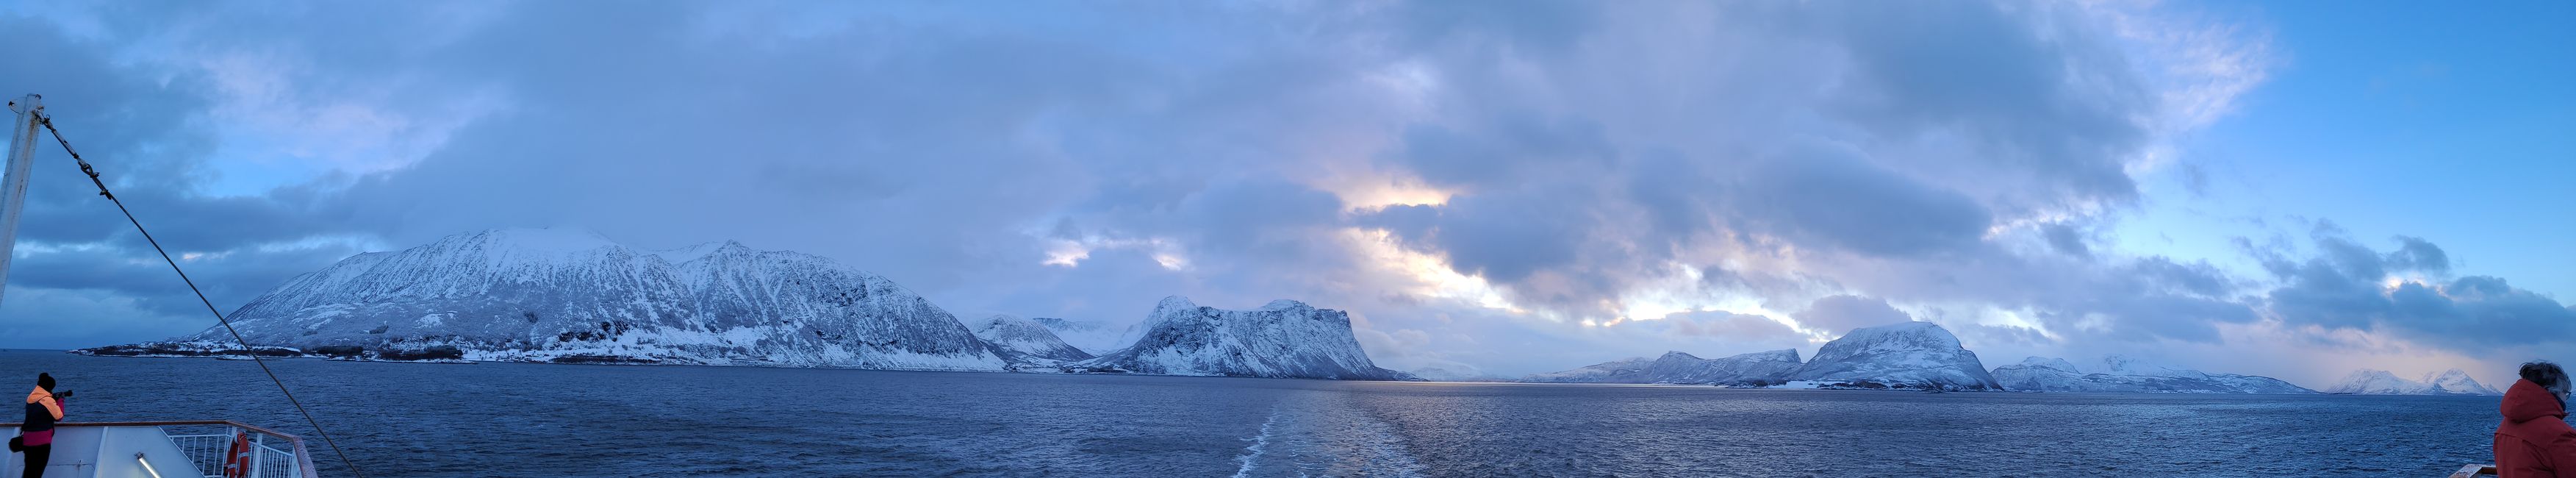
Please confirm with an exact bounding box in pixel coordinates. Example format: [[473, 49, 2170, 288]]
[[1994, 357, 2313, 393]]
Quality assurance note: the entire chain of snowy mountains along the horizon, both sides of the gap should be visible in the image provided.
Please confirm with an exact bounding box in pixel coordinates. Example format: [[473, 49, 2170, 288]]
[[80, 230, 2496, 396]]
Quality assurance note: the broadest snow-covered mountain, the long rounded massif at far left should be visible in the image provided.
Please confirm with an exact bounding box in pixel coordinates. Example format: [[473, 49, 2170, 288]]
[[100, 230, 1007, 369]]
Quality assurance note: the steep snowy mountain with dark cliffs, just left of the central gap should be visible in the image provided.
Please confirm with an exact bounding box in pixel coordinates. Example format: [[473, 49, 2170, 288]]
[[1066, 295, 1414, 379]]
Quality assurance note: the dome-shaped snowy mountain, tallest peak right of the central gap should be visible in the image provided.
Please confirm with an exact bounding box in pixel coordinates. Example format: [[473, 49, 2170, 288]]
[[1790, 323, 1999, 390]]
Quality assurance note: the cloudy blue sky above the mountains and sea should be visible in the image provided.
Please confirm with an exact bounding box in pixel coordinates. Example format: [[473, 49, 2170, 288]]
[[0, 0, 2576, 388]]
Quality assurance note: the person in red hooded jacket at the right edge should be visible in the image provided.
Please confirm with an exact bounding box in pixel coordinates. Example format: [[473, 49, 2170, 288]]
[[2496, 362, 2576, 478]]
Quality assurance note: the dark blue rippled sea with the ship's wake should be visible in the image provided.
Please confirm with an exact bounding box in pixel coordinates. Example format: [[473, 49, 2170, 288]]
[[0, 352, 2499, 478]]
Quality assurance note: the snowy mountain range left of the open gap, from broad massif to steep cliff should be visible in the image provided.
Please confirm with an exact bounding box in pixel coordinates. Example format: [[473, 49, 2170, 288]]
[[80, 230, 1412, 379]]
